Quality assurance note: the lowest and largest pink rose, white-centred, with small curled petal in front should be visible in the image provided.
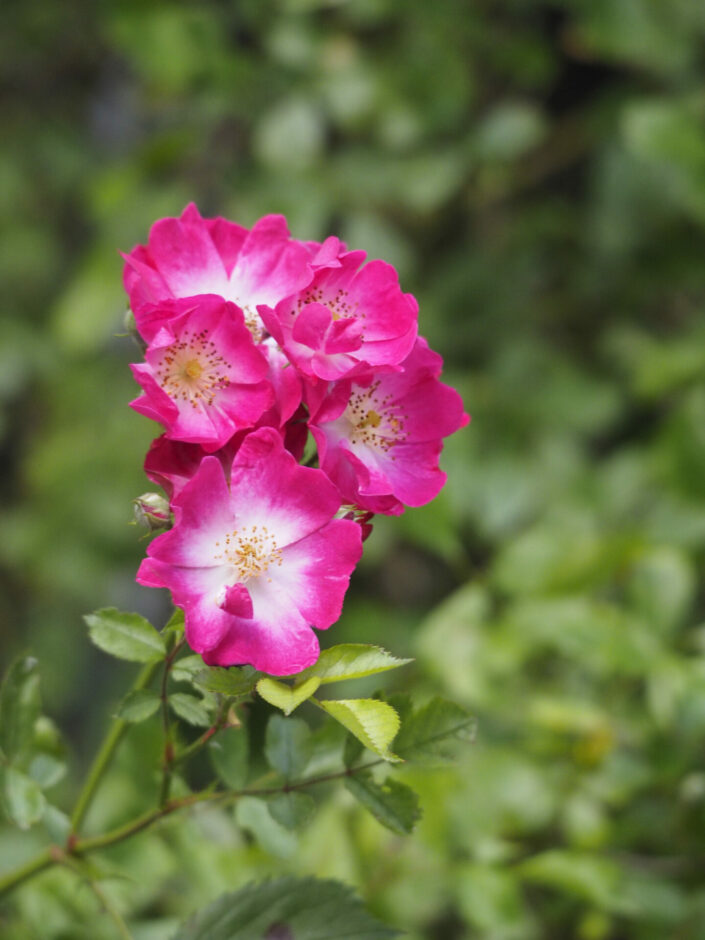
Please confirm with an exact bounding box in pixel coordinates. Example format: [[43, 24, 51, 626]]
[[137, 428, 362, 675]]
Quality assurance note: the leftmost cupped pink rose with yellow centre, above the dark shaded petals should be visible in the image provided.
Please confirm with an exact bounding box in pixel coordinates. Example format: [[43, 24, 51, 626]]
[[130, 295, 274, 451]]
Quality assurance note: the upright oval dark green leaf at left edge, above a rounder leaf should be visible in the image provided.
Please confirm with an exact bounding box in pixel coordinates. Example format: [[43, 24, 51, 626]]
[[0, 656, 41, 763]]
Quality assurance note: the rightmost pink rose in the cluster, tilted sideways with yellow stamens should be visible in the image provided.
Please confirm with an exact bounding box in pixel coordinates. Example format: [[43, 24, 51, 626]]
[[310, 337, 470, 515]]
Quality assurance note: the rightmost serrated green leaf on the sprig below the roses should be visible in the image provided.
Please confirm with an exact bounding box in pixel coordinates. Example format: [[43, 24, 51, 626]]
[[392, 698, 475, 763]]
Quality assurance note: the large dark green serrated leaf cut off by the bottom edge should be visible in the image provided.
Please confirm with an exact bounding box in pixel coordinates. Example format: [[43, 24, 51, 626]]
[[174, 877, 399, 940]]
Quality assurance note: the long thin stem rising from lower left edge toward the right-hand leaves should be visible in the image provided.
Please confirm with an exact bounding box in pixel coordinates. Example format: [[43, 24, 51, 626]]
[[0, 758, 383, 897]]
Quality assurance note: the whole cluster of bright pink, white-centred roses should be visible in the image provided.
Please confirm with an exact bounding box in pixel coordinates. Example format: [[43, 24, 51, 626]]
[[124, 205, 468, 675]]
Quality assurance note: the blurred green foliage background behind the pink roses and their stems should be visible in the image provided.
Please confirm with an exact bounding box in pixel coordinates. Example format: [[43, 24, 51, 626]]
[[0, 0, 705, 940]]
